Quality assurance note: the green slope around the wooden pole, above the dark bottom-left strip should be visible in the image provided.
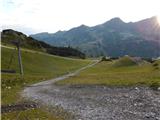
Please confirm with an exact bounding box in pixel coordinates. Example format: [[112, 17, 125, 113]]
[[1, 47, 90, 104]]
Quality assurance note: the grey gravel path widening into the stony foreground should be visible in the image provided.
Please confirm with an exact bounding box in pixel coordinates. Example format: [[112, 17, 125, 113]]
[[22, 63, 160, 120]]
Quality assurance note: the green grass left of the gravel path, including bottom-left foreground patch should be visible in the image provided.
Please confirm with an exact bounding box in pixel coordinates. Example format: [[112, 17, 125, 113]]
[[1, 48, 90, 120]]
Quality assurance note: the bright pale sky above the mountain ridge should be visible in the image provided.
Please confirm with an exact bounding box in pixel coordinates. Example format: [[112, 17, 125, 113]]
[[0, 0, 160, 34]]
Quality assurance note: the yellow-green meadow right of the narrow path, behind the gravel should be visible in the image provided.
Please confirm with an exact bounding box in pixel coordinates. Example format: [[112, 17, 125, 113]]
[[57, 61, 160, 86]]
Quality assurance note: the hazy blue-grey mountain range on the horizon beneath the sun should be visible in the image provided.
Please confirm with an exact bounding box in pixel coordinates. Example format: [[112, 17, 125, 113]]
[[31, 17, 160, 57]]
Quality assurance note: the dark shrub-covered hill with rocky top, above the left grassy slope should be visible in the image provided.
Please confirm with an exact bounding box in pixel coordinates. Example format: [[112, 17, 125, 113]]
[[1, 29, 85, 58]]
